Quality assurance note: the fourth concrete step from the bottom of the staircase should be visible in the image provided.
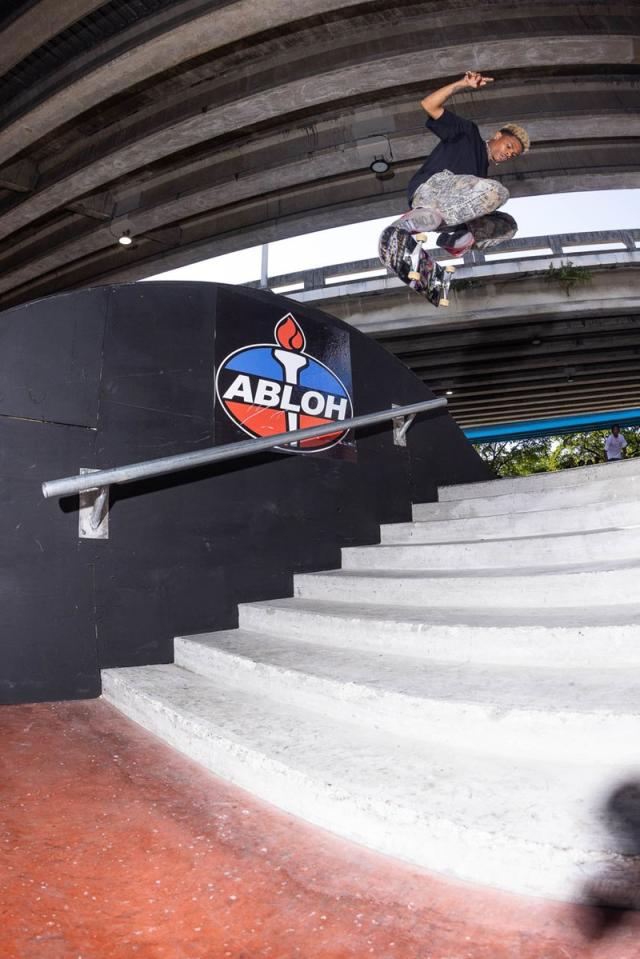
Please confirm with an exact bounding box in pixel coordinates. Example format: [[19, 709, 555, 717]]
[[294, 560, 640, 610]]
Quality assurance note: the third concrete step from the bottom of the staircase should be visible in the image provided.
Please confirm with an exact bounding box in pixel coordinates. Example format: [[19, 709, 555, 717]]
[[239, 598, 640, 668]]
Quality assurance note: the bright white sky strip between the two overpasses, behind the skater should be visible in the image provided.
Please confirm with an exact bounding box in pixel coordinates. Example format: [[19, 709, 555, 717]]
[[148, 190, 640, 283]]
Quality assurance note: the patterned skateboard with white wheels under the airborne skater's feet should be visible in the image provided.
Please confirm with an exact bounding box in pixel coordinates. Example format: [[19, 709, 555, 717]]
[[378, 224, 455, 306]]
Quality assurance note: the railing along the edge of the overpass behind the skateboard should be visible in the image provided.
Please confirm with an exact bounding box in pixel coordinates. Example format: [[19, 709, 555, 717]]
[[255, 230, 640, 295]]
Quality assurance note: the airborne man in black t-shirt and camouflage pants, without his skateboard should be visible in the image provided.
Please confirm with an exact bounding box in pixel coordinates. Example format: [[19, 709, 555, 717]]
[[393, 70, 529, 256]]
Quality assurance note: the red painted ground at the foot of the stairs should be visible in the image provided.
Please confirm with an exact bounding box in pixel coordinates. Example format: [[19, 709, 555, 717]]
[[0, 701, 640, 959]]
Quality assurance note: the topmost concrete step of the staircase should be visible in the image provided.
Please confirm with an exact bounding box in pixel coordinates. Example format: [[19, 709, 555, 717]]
[[438, 457, 640, 502]]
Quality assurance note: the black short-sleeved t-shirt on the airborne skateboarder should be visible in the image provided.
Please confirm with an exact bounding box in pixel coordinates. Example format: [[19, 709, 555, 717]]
[[408, 110, 489, 203]]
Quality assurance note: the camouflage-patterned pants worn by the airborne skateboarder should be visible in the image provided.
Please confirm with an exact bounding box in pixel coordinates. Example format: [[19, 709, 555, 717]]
[[394, 170, 518, 250]]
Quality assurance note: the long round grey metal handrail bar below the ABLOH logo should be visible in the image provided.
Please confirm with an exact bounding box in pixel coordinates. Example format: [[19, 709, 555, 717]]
[[42, 396, 447, 499]]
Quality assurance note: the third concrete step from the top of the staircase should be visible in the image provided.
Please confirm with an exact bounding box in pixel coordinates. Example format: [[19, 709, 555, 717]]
[[380, 500, 640, 543]]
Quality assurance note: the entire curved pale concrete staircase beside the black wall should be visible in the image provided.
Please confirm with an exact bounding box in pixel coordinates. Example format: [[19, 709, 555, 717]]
[[103, 460, 640, 899]]
